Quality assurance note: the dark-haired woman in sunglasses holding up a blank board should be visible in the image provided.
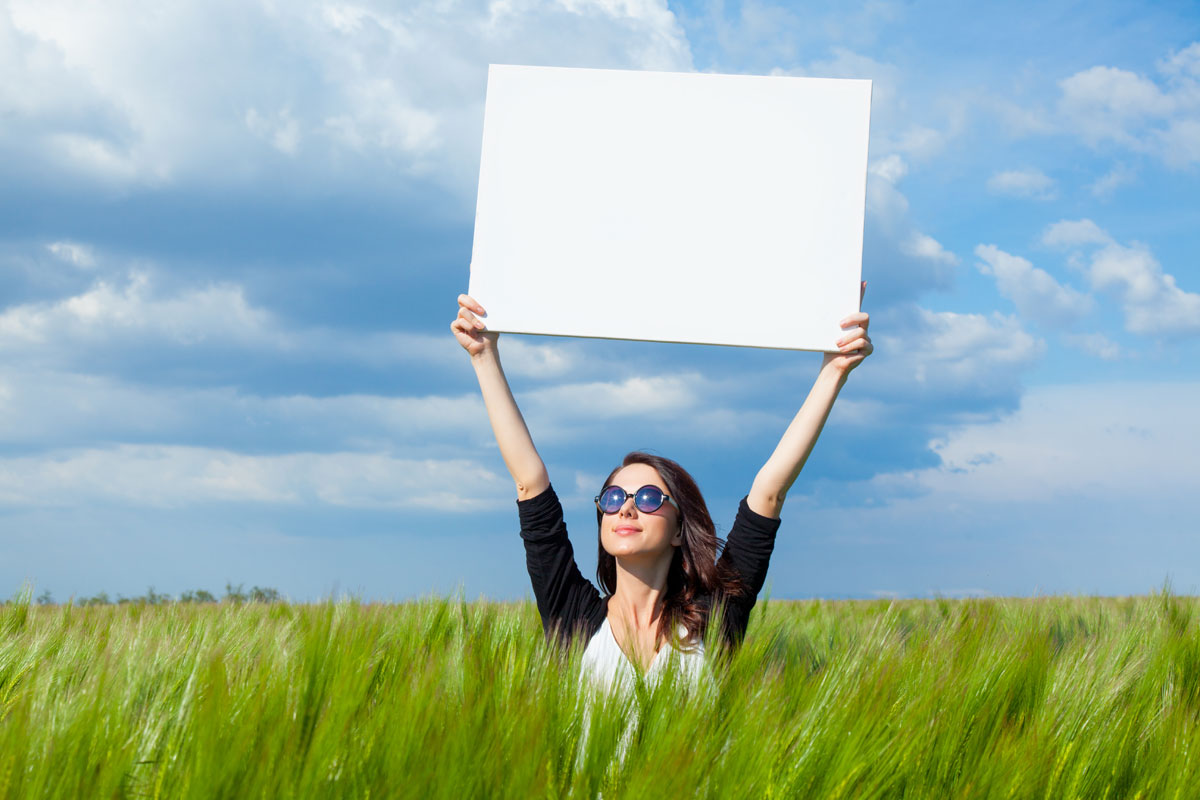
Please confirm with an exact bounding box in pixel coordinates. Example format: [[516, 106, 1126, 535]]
[[450, 291, 874, 680]]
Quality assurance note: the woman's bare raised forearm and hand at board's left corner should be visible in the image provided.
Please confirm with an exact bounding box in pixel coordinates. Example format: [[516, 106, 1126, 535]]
[[450, 295, 550, 500]]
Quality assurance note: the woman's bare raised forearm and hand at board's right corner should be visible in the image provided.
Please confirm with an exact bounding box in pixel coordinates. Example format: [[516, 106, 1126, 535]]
[[746, 283, 875, 519]]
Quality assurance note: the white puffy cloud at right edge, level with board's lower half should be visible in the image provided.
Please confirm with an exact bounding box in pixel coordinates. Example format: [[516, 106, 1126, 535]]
[[1042, 219, 1200, 335]]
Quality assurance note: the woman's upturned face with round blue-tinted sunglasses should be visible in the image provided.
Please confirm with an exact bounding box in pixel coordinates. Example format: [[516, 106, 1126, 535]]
[[600, 464, 682, 558]]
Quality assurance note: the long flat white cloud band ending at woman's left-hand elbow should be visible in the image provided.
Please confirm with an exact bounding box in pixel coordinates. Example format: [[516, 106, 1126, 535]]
[[0, 445, 512, 513]]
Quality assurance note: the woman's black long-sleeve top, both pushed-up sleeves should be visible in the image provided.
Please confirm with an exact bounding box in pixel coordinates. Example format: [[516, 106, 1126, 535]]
[[517, 487, 779, 645]]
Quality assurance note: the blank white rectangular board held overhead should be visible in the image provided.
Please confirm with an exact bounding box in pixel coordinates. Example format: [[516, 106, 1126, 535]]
[[468, 65, 871, 350]]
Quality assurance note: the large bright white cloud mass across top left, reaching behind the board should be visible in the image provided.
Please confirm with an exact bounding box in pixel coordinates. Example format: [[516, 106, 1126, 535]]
[[0, 0, 692, 190]]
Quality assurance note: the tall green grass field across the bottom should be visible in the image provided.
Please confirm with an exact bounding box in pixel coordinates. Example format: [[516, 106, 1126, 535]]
[[0, 593, 1200, 799]]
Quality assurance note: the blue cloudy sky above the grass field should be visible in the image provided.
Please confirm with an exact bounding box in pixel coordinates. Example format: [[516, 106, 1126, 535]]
[[0, 0, 1200, 601]]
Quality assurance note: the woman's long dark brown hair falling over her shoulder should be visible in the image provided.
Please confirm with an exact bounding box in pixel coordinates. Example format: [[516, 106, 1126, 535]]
[[596, 451, 745, 646]]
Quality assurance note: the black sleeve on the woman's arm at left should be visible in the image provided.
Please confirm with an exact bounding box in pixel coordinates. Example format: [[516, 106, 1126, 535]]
[[517, 487, 605, 642]]
